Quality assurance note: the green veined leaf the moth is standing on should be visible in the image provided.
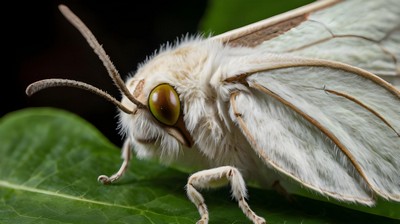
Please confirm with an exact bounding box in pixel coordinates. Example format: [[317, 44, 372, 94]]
[[0, 108, 396, 224]]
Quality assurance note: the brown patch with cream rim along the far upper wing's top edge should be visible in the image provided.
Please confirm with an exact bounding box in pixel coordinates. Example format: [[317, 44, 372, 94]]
[[212, 0, 342, 47]]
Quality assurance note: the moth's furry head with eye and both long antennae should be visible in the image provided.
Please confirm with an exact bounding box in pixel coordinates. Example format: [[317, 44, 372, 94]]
[[26, 5, 193, 161]]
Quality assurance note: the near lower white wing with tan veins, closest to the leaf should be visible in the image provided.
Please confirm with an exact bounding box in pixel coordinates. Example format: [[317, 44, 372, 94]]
[[227, 60, 400, 217]]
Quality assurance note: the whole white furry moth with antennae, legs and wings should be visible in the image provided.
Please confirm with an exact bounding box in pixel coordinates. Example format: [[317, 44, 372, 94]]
[[27, 0, 400, 223]]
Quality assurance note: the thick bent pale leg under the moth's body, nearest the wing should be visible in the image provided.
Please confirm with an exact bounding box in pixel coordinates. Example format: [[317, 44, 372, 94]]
[[186, 166, 266, 224]]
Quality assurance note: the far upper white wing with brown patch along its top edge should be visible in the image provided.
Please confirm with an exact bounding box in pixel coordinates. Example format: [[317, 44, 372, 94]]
[[214, 0, 400, 86]]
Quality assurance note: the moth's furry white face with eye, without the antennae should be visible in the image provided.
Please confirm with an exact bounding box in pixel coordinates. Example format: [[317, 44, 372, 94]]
[[120, 76, 193, 161]]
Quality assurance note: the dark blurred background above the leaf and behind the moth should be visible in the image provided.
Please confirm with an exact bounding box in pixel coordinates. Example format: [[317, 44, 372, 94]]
[[5, 0, 311, 146]]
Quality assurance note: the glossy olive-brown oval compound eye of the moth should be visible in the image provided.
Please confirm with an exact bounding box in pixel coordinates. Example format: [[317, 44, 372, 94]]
[[149, 84, 181, 126]]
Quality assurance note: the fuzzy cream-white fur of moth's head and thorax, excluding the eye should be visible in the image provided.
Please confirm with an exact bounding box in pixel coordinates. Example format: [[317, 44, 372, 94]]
[[120, 37, 268, 178]]
